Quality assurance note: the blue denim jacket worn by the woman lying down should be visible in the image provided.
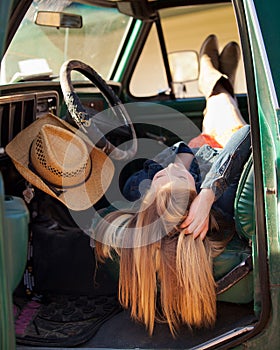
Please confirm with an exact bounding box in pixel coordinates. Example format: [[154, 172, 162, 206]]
[[123, 125, 251, 205]]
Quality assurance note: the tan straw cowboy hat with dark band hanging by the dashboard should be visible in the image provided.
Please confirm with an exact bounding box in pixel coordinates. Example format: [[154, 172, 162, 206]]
[[6, 114, 114, 210]]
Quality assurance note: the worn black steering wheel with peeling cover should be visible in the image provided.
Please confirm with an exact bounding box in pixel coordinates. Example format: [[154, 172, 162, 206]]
[[60, 60, 137, 160]]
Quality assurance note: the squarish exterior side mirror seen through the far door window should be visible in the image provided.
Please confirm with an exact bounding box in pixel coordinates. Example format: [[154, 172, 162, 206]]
[[168, 50, 199, 83]]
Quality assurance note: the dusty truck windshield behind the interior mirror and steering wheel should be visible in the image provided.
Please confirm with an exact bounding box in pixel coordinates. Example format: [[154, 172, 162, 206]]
[[0, 0, 130, 84]]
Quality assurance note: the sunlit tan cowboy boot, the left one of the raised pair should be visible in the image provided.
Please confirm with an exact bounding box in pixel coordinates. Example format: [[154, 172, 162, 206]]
[[198, 34, 223, 99]]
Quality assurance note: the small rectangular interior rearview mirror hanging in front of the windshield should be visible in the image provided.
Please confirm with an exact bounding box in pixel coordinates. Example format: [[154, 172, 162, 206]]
[[35, 11, 83, 28]]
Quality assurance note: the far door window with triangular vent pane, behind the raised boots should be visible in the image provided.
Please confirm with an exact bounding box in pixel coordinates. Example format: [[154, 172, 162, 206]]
[[130, 4, 246, 98]]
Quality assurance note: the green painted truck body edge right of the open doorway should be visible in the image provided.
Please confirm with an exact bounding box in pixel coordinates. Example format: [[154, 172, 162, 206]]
[[238, 0, 280, 349]]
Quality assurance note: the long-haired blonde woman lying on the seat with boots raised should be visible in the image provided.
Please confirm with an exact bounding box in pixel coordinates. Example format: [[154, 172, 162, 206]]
[[92, 35, 251, 335]]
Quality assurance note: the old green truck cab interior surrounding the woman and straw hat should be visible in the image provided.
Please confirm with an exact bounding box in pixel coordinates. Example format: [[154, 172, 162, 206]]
[[0, 0, 278, 350]]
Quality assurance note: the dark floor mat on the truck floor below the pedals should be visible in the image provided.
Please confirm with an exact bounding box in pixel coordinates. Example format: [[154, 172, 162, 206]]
[[14, 296, 121, 347]]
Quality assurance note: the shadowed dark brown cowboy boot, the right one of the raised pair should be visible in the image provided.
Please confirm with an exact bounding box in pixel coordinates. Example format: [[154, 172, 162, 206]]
[[219, 41, 241, 88]]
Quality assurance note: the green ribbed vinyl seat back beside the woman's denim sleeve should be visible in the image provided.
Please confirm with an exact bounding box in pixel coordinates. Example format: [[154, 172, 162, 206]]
[[234, 156, 256, 239]]
